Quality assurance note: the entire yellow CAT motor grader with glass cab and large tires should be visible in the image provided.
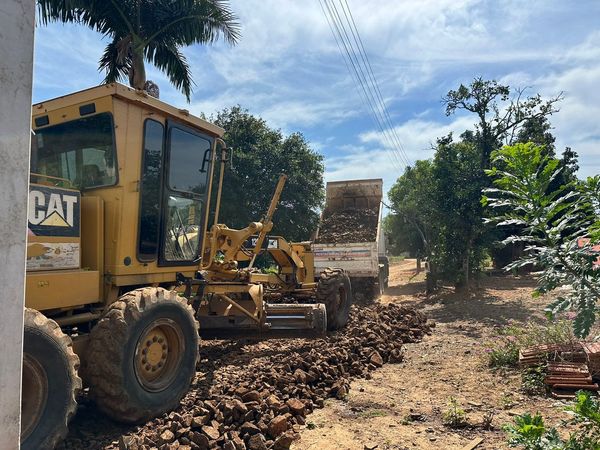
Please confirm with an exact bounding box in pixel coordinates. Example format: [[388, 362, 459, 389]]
[[21, 84, 352, 450]]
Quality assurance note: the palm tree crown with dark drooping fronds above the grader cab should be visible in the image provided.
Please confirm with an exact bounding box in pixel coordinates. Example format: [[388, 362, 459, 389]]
[[38, 0, 240, 102]]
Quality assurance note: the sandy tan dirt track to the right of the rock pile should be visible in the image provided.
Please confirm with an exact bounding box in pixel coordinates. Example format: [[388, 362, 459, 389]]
[[292, 260, 567, 450]]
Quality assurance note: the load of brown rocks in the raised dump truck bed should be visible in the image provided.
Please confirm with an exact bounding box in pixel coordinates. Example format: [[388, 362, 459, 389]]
[[316, 208, 379, 244]]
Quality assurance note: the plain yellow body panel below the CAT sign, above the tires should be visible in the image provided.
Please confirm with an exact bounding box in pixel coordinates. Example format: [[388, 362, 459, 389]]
[[25, 270, 100, 311]]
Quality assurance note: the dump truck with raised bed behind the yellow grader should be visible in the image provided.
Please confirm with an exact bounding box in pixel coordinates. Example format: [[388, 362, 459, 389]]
[[313, 178, 389, 298]]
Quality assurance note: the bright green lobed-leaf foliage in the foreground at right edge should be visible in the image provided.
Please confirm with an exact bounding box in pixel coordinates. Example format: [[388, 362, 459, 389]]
[[483, 143, 600, 336]]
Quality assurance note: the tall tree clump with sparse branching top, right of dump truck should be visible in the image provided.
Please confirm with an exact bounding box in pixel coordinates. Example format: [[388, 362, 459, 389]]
[[389, 78, 576, 288]]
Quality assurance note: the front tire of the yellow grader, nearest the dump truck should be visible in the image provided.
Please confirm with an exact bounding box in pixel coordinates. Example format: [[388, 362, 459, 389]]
[[317, 268, 352, 331]]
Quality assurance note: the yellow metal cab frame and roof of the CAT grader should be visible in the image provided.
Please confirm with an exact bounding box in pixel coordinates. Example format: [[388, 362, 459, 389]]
[[27, 83, 224, 306]]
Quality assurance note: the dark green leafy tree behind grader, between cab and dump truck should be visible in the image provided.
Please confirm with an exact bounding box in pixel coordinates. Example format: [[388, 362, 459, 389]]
[[212, 106, 324, 241]]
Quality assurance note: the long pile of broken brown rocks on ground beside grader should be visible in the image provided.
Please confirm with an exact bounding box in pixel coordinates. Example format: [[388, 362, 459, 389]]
[[59, 304, 430, 450]]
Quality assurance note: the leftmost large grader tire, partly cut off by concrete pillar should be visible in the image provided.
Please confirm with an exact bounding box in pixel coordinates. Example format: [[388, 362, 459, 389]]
[[21, 308, 81, 450]]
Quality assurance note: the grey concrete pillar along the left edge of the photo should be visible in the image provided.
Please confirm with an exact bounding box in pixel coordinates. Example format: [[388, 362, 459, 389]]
[[0, 0, 35, 450]]
